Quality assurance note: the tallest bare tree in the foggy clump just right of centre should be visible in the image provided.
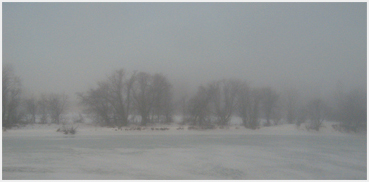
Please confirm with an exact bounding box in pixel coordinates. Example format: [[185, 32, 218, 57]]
[[213, 79, 241, 125]]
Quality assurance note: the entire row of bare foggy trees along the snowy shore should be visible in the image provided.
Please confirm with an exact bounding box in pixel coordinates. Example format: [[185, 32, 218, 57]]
[[2, 65, 366, 132]]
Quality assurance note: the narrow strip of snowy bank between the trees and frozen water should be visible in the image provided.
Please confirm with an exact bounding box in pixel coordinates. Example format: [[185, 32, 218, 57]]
[[3, 121, 366, 137]]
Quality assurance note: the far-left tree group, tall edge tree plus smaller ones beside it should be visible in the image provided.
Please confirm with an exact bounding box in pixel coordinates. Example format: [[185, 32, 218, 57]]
[[2, 65, 68, 128]]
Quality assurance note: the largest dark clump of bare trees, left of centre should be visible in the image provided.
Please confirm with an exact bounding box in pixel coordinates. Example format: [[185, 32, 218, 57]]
[[78, 69, 173, 128]]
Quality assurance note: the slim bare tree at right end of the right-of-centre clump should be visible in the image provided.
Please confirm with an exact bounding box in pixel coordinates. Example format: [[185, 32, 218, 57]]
[[261, 87, 279, 126]]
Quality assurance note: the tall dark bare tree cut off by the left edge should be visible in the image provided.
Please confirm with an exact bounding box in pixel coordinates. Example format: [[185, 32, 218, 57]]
[[2, 65, 21, 128]]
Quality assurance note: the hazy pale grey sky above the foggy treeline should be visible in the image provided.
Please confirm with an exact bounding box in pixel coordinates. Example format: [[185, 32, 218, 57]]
[[2, 3, 367, 101]]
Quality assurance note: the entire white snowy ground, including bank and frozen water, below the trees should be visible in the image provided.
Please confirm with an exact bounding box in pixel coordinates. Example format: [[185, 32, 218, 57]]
[[2, 118, 367, 180]]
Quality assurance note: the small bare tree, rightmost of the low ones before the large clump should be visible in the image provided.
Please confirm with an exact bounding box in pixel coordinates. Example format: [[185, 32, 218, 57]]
[[48, 94, 68, 124]]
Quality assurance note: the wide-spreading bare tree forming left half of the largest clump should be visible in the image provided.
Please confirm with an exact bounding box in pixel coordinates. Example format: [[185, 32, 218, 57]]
[[77, 69, 135, 127]]
